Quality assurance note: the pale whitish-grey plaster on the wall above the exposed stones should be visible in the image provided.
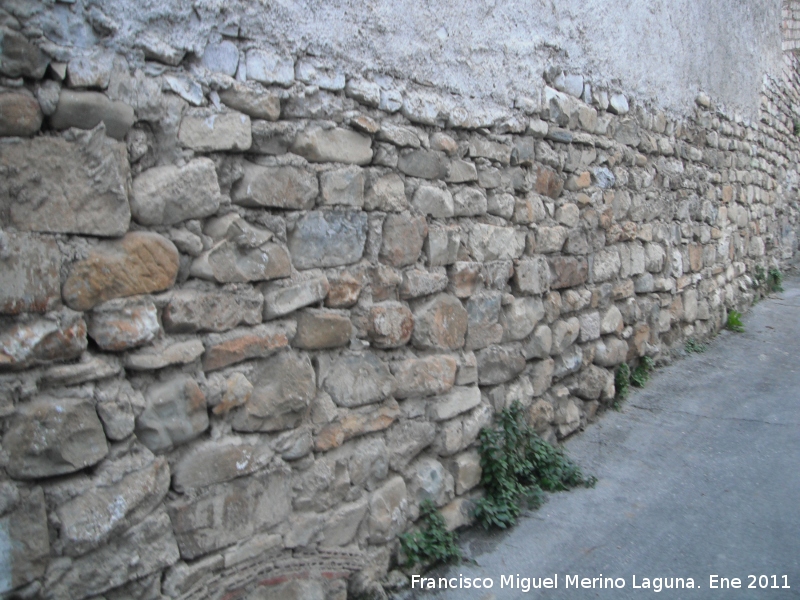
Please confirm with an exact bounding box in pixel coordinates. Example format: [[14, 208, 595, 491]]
[[23, 0, 781, 115]]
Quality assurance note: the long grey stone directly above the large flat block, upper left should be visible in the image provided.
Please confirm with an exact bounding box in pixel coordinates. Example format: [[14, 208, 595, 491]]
[[50, 89, 136, 140]]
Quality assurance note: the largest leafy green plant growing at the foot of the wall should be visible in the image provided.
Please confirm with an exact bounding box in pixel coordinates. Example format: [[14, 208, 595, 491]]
[[475, 402, 597, 529]]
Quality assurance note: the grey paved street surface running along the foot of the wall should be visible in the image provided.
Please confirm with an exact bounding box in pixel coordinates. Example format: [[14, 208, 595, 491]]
[[416, 278, 800, 600]]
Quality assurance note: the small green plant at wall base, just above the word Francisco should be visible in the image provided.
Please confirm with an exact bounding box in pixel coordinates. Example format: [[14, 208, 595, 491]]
[[400, 499, 461, 567]]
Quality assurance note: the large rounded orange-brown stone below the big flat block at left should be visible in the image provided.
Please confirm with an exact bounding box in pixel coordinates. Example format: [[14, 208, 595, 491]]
[[62, 231, 178, 310]]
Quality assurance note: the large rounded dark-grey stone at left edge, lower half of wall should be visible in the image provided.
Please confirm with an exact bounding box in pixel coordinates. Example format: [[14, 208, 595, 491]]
[[3, 393, 108, 479]]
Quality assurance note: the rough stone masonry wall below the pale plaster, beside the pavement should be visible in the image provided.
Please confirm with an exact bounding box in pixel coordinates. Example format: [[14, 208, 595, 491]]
[[0, 2, 800, 600]]
